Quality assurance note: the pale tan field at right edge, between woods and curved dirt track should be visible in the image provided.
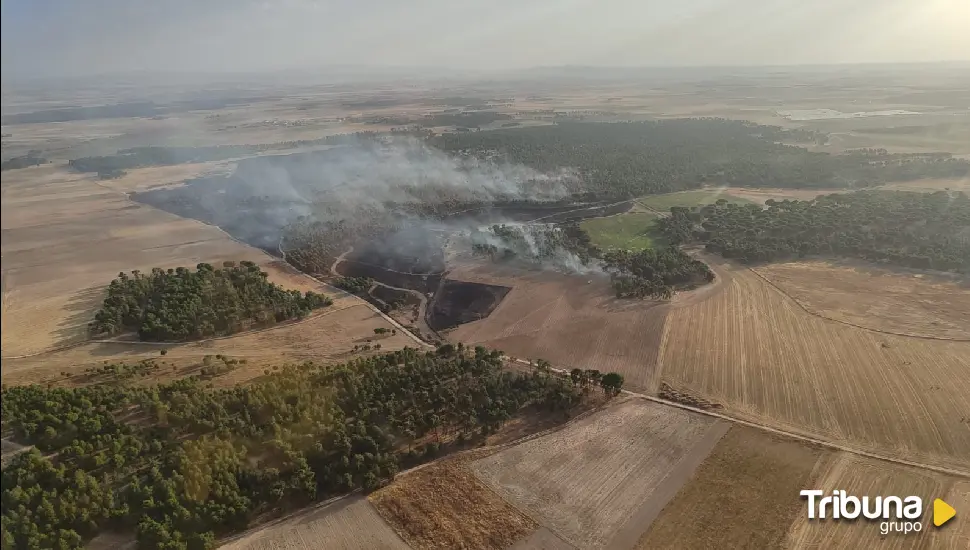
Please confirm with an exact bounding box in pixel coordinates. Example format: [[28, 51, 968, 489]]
[[756, 261, 970, 340]]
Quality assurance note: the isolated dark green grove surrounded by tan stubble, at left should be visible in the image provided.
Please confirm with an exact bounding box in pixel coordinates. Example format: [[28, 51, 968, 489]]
[[90, 261, 333, 341]]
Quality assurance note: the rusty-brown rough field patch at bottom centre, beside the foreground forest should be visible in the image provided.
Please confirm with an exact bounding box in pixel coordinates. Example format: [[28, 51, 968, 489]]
[[370, 461, 538, 550]]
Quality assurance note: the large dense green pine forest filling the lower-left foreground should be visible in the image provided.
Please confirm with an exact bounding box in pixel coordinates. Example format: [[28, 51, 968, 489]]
[[2, 344, 581, 550]]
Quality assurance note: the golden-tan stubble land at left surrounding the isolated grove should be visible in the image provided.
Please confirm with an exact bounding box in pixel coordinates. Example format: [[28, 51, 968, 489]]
[[2, 165, 413, 382]]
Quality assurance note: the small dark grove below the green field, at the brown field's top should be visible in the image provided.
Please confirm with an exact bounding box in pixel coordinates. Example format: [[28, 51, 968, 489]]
[[602, 246, 714, 299]]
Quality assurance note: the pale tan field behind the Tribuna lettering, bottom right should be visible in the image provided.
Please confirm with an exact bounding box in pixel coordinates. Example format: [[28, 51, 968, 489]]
[[787, 453, 954, 549]]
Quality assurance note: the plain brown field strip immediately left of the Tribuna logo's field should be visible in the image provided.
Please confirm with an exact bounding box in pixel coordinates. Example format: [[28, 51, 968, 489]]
[[637, 426, 827, 550]]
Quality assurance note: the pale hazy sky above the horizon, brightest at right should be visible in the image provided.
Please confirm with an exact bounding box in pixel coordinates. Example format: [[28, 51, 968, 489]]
[[0, 0, 970, 75]]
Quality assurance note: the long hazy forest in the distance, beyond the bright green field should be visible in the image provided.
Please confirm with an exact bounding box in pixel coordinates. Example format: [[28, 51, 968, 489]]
[[429, 119, 970, 198]]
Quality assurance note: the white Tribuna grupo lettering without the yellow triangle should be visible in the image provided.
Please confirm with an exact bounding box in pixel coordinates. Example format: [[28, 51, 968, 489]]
[[799, 490, 923, 535]]
